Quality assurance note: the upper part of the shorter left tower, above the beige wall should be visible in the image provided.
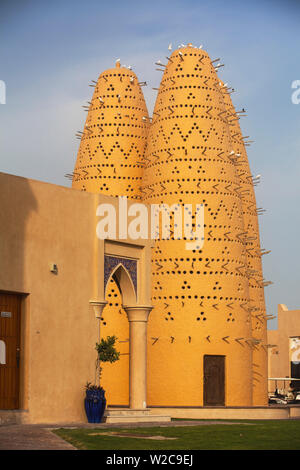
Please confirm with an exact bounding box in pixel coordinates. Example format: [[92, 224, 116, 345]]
[[72, 61, 149, 199]]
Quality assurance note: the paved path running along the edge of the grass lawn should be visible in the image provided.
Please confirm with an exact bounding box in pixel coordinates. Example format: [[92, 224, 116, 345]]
[[0, 420, 248, 450]]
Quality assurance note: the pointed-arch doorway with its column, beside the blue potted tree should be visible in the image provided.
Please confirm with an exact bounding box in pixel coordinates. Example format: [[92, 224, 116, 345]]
[[90, 246, 153, 410]]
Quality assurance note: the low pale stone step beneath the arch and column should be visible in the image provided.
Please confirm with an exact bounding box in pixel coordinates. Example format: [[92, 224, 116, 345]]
[[103, 408, 171, 423]]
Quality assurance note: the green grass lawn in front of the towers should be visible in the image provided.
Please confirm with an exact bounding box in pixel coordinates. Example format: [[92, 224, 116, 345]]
[[53, 420, 300, 450]]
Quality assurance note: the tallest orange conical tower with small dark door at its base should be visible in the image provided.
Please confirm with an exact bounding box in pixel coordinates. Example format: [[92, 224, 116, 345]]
[[143, 45, 255, 406]]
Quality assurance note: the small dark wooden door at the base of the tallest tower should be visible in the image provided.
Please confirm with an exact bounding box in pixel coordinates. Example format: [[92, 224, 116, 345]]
[[203, 355, 225, 406]]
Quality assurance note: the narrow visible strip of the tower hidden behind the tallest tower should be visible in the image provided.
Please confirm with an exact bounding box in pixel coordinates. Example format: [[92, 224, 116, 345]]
[[224, 91, 268, 406]]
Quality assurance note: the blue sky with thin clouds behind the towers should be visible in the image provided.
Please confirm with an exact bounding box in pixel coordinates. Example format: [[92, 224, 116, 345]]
[[0, 0, 300, 328]]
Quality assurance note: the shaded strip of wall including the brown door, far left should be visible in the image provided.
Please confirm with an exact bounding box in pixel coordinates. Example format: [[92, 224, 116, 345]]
[[0, 173, 38, 409]]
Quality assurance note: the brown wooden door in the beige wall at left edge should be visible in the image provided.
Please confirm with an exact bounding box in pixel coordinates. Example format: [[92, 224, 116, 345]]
[[0, 293, 21, 410]]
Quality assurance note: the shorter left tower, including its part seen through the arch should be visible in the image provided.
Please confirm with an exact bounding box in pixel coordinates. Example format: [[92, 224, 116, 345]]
[[72, 61, 149, 405]]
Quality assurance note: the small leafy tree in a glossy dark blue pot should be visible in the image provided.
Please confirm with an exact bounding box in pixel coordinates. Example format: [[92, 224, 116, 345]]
[[84, 336, 120, 423]]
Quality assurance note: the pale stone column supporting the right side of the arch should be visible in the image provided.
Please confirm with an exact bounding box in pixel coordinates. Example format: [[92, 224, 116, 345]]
[[124, 305, 153, 409]]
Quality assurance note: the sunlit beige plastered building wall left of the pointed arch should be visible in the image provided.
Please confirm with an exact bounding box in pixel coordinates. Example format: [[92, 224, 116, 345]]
[[0, 173, 150, 423]]
